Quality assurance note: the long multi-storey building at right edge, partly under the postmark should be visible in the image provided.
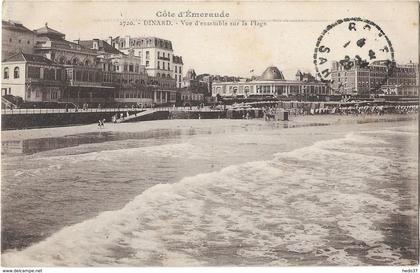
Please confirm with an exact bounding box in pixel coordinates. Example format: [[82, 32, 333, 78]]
[[331, 61, 419, 96]]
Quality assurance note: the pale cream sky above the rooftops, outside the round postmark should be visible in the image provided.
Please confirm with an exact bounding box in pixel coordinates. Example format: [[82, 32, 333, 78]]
[[3, 0, 419, 79]]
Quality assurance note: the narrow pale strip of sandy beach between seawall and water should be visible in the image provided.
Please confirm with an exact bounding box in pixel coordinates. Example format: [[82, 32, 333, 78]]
[[1, 113, 418, 141]]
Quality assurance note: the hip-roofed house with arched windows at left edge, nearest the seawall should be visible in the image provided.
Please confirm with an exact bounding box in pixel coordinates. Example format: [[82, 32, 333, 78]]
[[1, 52, 65, 102]]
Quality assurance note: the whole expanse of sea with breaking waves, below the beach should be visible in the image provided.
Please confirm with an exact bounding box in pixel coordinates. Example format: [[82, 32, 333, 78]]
[[2, 121, 418, 266]]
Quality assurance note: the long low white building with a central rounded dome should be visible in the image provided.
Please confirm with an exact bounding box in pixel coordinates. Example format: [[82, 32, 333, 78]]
[[212, 66, 330, 99]]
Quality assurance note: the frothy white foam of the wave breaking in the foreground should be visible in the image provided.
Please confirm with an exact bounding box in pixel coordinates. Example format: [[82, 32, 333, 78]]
[[2, 131, 414, 266]]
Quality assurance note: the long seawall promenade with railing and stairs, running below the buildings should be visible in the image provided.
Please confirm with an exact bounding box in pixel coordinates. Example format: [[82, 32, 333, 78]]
[[1, 101, 418, 130]]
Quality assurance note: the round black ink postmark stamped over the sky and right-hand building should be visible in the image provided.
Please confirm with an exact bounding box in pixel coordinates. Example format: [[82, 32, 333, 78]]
[[313, 17, 396, 95]]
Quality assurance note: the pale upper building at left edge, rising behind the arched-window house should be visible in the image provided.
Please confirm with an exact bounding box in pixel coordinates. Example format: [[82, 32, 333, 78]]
[[1, 20, 36, 60]]
